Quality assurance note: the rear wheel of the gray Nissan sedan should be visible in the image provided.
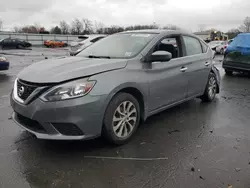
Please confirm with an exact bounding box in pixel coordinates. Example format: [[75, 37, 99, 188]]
[[201, 72, 218, 102]]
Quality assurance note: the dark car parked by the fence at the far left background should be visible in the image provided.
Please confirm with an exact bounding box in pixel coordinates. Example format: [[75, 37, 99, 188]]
[[0, 38, 32, 49]]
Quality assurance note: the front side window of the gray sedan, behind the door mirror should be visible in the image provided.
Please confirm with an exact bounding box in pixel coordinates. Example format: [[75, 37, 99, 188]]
[[154, 37, 180, 59]]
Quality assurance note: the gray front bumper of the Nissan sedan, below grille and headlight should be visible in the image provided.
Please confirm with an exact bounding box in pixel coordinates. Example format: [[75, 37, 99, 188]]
[[11, 94, 106, 140]]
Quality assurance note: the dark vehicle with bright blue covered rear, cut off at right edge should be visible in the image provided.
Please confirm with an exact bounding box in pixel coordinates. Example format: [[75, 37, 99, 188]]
[[222, 33, 250, 75]]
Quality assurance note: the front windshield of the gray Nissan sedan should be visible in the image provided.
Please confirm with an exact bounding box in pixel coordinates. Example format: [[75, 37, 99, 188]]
[[79, 33, 156, 58]]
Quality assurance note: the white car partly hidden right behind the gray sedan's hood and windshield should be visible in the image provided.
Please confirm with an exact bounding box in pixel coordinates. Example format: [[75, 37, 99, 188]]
[[69, 35, 106, 56]]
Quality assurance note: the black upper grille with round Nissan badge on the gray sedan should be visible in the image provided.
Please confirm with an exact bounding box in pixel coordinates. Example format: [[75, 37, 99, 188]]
[[17, 80, 37, 101]]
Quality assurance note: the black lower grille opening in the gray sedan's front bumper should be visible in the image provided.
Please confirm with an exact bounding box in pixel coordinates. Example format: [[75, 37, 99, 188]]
[[16, 113, 46, 133]]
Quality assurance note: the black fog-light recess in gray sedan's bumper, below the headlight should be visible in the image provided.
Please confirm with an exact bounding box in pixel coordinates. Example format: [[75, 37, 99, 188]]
[[52, 123, 83, 136]]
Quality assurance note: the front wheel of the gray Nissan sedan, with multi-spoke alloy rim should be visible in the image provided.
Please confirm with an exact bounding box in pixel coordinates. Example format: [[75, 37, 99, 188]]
[[102, 93, 140, 145]]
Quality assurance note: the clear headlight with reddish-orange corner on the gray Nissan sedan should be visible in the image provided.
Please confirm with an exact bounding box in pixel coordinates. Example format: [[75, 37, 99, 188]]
[[41, 80, 96, 101]]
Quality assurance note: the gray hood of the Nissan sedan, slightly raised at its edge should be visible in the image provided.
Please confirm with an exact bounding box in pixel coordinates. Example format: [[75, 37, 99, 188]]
[[17, 56, 127, 83]]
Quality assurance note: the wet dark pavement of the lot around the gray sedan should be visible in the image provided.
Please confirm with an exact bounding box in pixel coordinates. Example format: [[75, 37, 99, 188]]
[[0, 48, 250, 188]]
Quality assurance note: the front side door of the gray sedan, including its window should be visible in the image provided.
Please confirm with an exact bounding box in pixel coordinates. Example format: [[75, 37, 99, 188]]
[[147, 35, 188, 111]]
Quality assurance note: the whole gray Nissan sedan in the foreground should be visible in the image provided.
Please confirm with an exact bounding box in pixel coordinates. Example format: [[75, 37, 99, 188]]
[[11, 30, 220, 144]]
